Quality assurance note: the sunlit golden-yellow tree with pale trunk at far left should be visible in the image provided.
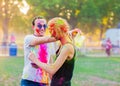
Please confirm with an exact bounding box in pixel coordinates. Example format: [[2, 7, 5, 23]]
[[0, 0, 29, 42]]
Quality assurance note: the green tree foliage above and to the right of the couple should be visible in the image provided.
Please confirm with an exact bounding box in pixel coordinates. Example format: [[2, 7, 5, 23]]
[[28, 0, 120, 38]]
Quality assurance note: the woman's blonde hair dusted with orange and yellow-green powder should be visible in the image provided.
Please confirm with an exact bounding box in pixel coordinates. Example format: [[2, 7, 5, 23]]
[[48, 17, 70, 35]]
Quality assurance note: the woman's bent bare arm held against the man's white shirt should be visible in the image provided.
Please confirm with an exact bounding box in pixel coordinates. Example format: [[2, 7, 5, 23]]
[[29, 44, 71, 75]]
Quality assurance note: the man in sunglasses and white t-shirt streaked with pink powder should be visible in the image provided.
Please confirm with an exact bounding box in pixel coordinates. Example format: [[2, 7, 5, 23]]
[[21, 17, 56, 86]]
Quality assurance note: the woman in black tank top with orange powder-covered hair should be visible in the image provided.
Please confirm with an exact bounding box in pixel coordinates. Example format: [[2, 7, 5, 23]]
[[29, 17, 75, 86]]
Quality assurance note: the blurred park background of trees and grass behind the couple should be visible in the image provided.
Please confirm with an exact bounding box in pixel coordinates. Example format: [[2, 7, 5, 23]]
[[0, 0, 120, 86]]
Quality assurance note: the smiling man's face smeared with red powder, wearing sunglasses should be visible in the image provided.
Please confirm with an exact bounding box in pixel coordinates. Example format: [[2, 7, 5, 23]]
[[34, 19, 47, 36]]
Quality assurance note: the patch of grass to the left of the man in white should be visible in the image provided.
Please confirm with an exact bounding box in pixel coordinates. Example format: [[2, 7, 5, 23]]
[[0, 57, 23, 86]]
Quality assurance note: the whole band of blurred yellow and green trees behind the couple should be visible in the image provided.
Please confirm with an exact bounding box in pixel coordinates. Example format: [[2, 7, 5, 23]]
[[0, 0, 120, 44]]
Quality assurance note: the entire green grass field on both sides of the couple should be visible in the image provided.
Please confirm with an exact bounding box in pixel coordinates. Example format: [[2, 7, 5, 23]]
[[0, 56, 120, 86]]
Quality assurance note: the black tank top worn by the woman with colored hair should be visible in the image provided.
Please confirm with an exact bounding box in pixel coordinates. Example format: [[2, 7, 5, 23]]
[[51, 43, 76, 86]]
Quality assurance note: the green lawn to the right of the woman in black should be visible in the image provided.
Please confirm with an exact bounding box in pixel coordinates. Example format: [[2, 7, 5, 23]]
[[72, 54, 120, 86]]
